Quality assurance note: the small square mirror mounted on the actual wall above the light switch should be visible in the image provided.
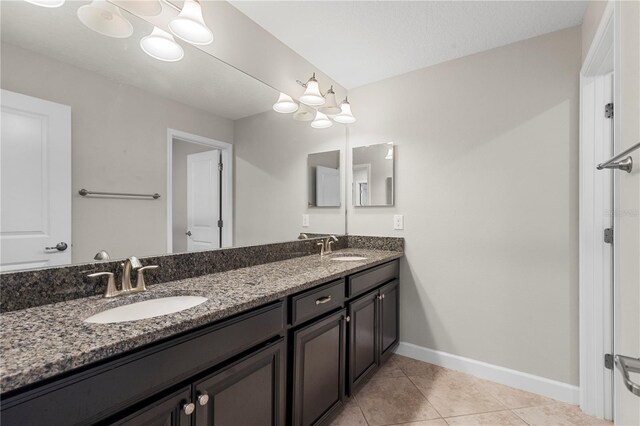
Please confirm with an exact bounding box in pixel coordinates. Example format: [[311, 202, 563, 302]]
[[352, 142, 395, 207]]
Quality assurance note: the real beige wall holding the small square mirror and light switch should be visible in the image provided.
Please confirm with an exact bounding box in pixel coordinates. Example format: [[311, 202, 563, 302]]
[[348, 27, 581, 384]]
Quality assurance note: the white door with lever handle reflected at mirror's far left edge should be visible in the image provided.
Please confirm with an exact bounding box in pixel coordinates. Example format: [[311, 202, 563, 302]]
[[0, 90, 71, 271]]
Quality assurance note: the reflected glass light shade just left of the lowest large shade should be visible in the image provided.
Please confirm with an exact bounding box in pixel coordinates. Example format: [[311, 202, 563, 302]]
[[78, 0, 133, 38]]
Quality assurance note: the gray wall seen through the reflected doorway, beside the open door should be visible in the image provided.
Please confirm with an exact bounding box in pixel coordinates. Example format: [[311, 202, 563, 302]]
[[171, 139, 219, 253]]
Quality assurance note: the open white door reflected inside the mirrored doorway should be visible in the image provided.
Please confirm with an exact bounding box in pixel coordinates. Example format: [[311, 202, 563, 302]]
[[187, 149, 220, 251]]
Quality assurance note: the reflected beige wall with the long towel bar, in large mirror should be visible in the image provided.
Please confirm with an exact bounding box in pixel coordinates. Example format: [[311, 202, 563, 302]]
[[1, 43, 233, 263]]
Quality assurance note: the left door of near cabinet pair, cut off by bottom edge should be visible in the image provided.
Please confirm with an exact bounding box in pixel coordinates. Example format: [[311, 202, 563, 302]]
[[111, 386, 194, 426]]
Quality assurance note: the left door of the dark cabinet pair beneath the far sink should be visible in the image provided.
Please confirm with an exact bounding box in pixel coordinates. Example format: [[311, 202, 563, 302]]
[[348, 290, 378, 395]]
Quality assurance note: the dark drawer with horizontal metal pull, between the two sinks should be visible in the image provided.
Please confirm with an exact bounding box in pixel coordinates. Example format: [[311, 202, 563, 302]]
[[290, 280, 344, 325]]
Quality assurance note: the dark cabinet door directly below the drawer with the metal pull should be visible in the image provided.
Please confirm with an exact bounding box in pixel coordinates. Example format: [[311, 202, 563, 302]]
[[291, 309, 346, 426]]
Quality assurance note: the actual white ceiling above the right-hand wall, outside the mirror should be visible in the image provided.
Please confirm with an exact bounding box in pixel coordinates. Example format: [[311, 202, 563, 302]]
[[231, 0, 587, 89]]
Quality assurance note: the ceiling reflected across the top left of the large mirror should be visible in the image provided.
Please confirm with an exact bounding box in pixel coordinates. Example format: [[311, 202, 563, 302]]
[[0, 1, 278, 120]]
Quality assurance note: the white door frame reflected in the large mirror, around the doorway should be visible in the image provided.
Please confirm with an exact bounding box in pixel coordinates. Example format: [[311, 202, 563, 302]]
[[167, 128, 233, 253]]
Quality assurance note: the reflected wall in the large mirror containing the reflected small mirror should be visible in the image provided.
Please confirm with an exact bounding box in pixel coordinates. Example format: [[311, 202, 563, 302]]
[[234, 111, 345, 245]]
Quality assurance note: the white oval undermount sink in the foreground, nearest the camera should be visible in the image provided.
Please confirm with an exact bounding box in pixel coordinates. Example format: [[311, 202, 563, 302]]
[[84, 296, 208, 324]]
